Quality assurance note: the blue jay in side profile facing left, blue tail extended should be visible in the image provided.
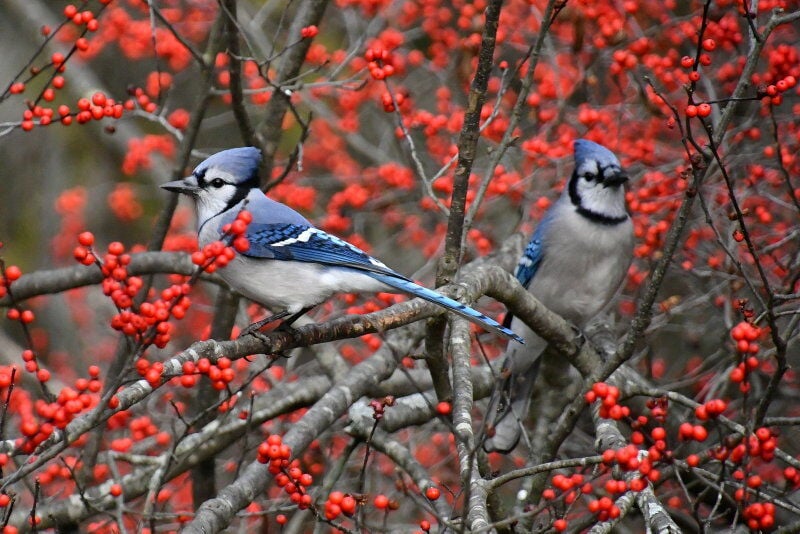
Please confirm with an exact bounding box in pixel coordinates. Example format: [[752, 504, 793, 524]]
[[161, 147, 522, 343]]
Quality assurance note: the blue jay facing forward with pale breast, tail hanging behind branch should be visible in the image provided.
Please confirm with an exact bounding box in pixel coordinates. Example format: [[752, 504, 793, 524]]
[[484, 139, 633, 452]]
